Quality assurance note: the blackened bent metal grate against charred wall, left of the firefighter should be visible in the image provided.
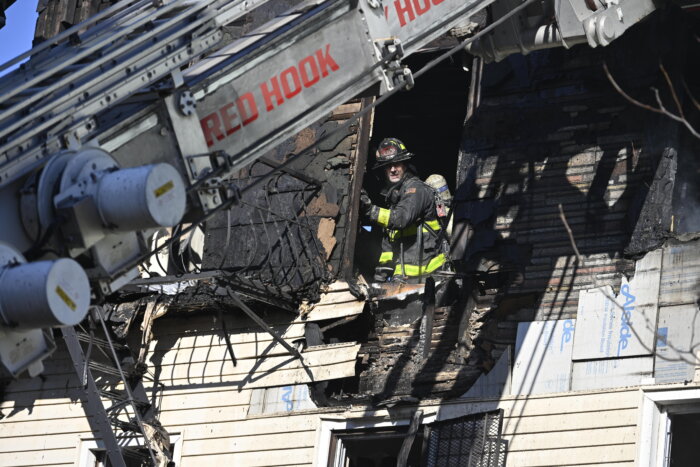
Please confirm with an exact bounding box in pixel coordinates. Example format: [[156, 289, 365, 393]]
[[204, 162, 331, 306]]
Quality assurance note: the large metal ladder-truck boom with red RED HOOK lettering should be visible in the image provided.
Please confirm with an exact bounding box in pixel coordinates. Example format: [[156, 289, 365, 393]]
[[0, 0, 655, 380]]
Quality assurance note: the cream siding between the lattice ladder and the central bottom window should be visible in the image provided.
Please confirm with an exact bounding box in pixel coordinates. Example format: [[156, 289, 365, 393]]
[[147, 315, 330, 466]]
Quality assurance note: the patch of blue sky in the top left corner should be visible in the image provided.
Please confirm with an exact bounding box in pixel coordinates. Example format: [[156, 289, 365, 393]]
[[0, 0, 37, 75]]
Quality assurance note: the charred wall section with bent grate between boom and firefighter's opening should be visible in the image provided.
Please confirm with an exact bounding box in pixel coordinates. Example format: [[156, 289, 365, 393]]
[[204, 102, 370, 305]]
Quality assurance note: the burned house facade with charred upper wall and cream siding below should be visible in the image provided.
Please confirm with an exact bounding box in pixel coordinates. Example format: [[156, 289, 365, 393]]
[[0, 0, 700, 467]]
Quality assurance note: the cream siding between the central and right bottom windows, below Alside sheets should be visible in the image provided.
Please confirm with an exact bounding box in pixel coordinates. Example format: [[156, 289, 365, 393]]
[[440, 389, 640, 467]]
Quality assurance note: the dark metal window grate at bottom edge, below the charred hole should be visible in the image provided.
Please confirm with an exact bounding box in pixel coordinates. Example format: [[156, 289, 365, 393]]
[[425, 410, 507, 467]]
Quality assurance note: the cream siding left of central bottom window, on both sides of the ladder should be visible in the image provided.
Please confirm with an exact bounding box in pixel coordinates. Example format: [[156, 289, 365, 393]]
[[0, 310, 350, 466]]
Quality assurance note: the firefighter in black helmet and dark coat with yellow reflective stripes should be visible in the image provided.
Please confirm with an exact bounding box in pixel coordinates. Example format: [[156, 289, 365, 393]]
[[360, 138, 445, 282]]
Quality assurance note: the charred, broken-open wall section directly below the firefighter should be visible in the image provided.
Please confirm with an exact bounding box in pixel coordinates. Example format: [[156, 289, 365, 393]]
[[322, 279, 482, 406]]
